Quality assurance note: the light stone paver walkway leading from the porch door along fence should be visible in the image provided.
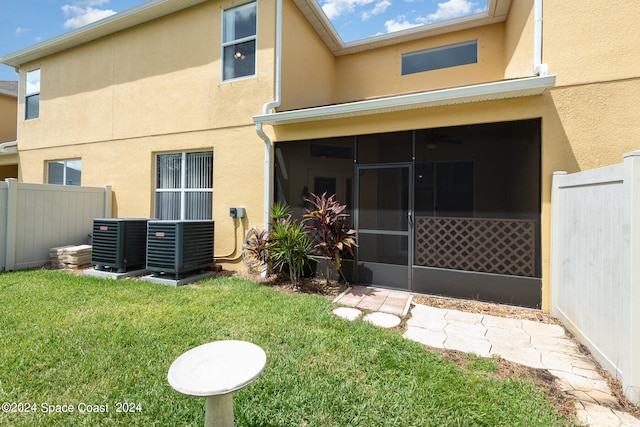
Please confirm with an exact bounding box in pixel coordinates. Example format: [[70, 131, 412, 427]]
[[334, 286, 640, 427]]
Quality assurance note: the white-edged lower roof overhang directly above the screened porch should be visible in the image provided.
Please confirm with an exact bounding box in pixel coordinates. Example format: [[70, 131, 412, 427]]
[[253, 75, 556, 126]]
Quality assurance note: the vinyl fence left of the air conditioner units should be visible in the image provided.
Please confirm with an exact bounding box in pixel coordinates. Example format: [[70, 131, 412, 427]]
[[0, 179, 111, 271]]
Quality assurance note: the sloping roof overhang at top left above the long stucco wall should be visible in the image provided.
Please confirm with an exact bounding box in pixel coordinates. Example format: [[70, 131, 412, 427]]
[[0, 0, 207, 67]]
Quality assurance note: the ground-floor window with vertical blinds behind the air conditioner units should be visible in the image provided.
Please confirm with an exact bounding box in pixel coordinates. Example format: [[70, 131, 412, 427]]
[[155, 151, 213, 219]]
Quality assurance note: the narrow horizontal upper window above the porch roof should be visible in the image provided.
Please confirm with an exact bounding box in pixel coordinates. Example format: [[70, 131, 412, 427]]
[[402, 40, 478, 76]]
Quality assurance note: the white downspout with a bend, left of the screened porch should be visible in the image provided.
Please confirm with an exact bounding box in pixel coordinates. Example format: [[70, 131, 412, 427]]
[[256, 0, 282, 234]]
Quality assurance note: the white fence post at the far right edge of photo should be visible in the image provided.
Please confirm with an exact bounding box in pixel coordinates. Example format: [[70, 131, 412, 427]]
[[620, 151, 640, 405]]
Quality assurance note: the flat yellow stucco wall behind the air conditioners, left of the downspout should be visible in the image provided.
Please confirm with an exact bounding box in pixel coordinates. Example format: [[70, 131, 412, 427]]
[[14, 0, 275, 268]]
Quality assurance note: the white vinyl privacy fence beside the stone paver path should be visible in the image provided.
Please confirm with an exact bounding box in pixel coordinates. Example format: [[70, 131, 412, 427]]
[[551, 151, 640, 404]]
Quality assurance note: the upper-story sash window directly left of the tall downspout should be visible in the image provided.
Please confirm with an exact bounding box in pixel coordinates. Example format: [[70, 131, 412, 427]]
[[222, 2, 257, 80]]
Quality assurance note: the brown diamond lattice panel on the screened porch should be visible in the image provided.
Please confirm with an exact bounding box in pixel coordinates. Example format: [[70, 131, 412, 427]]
[[415, 217, 536, 277]]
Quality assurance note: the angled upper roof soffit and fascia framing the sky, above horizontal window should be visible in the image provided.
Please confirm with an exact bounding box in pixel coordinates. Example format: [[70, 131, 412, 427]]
[[293, 0, 512, 56]]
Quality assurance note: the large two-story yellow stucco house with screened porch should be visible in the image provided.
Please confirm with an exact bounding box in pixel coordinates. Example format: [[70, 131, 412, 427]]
[[0, 0, 640, 309]]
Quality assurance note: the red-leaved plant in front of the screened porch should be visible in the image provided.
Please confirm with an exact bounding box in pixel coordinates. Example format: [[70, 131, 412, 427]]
[[303, 193, 358, 283]]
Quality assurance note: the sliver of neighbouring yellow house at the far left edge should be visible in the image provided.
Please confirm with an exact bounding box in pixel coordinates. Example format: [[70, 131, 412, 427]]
[[0, 80, 18, 181]]
